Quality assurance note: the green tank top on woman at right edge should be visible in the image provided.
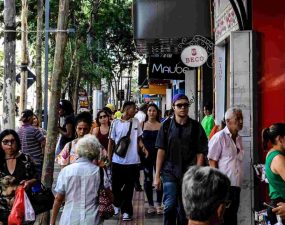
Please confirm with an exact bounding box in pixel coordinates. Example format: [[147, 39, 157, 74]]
[[265, 150, 285, 199]]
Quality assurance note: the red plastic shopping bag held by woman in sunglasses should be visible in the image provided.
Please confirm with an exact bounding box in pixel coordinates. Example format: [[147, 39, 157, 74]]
[[8, 186, 25, 225]]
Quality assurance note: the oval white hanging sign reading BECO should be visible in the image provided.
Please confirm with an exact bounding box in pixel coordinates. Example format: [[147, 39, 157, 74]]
[[181, 45, 208, 67]]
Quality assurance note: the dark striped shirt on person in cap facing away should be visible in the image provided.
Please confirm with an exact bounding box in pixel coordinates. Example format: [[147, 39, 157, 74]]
[[18, 124, 45, 166]]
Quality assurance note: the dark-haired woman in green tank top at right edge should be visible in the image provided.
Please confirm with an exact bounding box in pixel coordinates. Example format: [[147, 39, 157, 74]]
[[262, 123, 285, 224]]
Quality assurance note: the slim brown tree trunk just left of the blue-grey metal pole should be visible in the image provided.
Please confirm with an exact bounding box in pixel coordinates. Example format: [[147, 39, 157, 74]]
[[36, 0, 44, 124]]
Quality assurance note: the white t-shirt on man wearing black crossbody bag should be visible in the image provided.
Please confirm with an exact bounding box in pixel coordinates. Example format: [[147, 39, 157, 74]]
[[109, 118, 142, 165]]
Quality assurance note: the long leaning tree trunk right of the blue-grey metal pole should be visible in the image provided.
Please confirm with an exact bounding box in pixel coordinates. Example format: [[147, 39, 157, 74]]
[[39, 0, 69, 222]]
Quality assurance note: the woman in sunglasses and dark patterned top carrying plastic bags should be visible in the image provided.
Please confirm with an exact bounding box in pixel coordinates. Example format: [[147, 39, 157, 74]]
[[0, 129, 38, 225]]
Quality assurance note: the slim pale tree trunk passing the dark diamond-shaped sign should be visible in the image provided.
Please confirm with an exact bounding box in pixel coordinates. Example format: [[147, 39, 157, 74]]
[[20, 0, 28, 112]]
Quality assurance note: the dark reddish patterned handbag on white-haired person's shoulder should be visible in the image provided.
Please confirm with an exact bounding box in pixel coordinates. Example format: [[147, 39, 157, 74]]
[[98, 167, 115, 219]]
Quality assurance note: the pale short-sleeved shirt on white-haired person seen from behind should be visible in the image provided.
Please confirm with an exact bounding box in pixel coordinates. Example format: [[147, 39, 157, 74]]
[[55, 158, 109, 225]]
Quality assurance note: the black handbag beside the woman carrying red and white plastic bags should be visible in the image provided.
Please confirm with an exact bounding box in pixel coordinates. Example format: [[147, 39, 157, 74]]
[[29, 184, 54, 215]]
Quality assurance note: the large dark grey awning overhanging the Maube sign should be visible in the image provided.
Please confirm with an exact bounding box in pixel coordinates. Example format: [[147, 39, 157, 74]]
[[133, 0, 211, 54]]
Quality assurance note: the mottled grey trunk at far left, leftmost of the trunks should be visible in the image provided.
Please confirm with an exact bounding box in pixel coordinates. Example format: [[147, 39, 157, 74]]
[[1, 0, 16, 130]]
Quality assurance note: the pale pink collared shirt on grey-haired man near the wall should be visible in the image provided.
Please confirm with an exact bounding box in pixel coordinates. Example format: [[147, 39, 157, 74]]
[[208, 127, 244, 187]]
